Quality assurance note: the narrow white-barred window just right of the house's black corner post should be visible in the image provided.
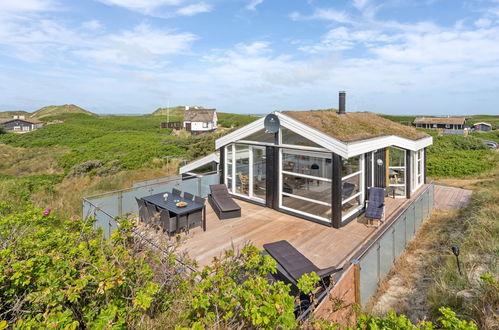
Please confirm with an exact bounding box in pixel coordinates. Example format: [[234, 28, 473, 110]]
[[341, 156, 364, 220]]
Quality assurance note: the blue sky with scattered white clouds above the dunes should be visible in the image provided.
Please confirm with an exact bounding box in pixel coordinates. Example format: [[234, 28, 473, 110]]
[[0, 0, 499, 115]]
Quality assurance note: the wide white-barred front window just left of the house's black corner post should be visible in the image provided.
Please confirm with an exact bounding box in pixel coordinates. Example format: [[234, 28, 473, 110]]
[[280, 149, 332, 221]]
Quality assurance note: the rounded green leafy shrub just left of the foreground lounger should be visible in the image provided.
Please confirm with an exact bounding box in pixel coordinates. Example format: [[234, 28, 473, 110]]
[[184, 246, 296, 329]]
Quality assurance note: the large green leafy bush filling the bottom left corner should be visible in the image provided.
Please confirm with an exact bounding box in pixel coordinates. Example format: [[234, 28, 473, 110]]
[[0, 202, 186, 329]]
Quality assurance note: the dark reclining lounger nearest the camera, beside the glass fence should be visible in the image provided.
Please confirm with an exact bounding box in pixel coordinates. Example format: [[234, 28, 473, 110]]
[[263, 241, 343, 287]]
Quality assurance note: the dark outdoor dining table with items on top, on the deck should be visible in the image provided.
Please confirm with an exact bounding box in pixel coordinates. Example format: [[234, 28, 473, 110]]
[[142, 192, 206, 231]]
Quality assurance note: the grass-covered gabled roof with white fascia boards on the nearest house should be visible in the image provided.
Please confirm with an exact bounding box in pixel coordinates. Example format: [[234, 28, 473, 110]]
[[215, 110, 433, 158]]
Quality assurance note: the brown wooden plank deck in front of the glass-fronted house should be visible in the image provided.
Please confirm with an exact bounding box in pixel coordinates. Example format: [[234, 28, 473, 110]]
[[181, 188, 430, 267]]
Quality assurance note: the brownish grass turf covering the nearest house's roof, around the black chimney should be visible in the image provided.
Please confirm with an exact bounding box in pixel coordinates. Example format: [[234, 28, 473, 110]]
[[282, 110, 428, 142]]
